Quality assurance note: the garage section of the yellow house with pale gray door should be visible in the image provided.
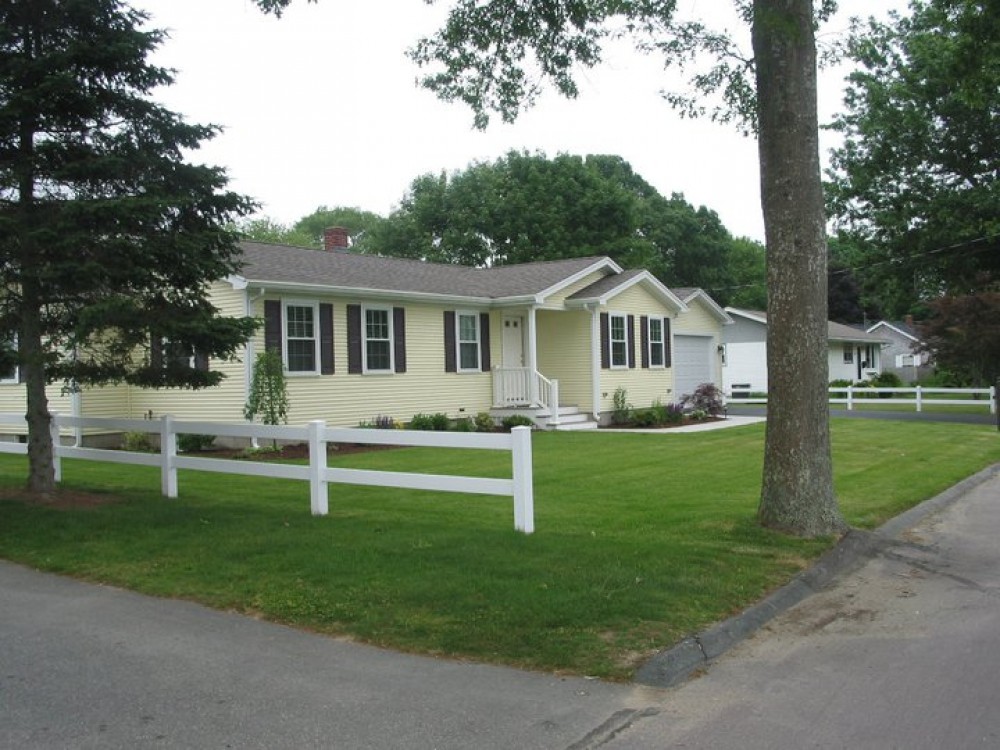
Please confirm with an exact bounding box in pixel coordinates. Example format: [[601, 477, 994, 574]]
[[670, 288, 733, 401]]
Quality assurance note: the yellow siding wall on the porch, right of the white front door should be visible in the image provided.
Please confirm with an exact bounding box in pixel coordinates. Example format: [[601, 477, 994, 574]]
[[535, 310, 593, 411]]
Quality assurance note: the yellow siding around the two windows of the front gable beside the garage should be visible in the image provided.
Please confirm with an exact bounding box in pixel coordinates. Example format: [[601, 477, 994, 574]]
[[600, 284, 677, 412]]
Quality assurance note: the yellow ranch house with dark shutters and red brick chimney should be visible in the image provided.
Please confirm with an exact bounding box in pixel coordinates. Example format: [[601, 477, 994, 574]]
[[0, 233, 726, 438]]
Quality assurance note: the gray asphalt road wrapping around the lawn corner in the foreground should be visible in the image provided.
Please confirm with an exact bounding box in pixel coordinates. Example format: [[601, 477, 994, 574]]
[[0, 473, 1000, 750]]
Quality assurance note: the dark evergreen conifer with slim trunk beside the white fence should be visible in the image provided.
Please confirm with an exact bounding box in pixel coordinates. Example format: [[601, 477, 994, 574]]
[[0, 0, 254, 492]]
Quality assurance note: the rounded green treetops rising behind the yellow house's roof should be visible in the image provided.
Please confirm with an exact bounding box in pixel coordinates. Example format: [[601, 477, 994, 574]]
[[362, 152, 733, 293]]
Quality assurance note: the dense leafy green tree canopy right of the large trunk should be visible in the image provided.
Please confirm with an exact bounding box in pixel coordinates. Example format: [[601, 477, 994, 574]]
[[828, 0, 1000, 316]]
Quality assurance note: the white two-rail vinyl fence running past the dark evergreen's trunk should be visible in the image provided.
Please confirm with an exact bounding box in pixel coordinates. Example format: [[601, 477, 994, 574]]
[[0, 414, 535, 534]]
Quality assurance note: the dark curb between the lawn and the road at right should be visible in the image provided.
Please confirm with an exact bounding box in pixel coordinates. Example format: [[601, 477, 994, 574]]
[[634, 464, 1000, 688]]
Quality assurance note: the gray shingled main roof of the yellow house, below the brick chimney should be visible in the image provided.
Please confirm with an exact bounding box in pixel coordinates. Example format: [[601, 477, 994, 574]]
[[239, 242, 608, 299]]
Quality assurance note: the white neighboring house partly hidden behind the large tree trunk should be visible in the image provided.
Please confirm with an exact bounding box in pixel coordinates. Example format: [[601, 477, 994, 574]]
[[722, 307, 885, 392]]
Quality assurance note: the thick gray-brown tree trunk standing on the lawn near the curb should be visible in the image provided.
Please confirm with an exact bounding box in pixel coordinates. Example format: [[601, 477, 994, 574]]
[[753, 0, 845, 536]]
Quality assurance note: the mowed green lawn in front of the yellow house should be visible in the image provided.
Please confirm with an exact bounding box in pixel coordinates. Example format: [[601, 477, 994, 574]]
[[0, 419, 1000, 679]]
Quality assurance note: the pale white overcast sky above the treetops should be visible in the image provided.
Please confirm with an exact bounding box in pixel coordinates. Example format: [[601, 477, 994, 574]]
[[133, 0, 904, 240]]
